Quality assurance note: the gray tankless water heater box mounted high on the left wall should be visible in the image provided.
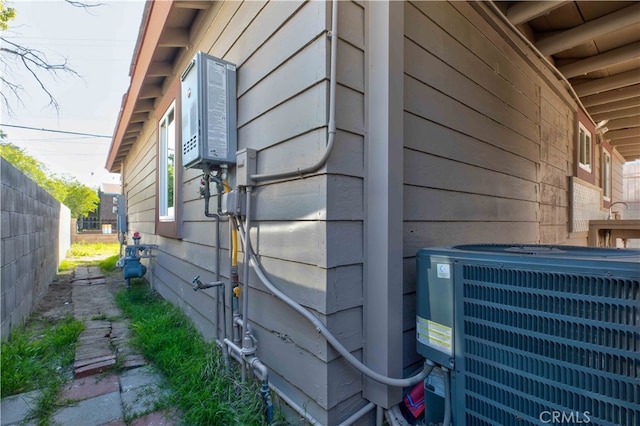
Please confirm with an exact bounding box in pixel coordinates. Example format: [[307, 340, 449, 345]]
[[180, 52, 238, 168]]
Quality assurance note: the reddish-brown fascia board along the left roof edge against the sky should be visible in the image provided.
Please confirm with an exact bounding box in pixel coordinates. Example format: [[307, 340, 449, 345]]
[[106, 0, 173, 170]]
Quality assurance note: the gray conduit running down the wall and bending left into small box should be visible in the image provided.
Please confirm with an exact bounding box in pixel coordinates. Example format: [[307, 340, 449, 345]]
[[249, 0, 338, 182]]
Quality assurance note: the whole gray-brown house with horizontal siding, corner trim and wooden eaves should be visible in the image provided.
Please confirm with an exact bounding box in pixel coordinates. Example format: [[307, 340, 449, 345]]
[[107, 1, 640, 424]]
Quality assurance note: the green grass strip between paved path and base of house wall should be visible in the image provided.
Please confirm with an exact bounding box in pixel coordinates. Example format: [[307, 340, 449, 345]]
[[116, 280, 264, 425]]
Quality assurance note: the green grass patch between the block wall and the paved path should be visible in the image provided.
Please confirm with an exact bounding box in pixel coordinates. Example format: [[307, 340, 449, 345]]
[[0, 316, 84, 424]]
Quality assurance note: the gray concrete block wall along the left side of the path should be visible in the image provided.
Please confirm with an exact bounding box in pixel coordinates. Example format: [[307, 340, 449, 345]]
[[0, 158, 71, 339]]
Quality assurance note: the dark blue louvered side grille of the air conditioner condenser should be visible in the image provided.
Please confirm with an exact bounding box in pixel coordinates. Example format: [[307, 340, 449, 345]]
[[452, 256, 640, 426]]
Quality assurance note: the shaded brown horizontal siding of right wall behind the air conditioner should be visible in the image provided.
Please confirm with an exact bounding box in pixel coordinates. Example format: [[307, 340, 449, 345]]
[[403, 1, 621, 376]]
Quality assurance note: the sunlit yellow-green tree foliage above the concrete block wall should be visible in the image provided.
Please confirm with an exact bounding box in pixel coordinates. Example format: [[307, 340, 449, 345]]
[[0, 141, 100, 217]]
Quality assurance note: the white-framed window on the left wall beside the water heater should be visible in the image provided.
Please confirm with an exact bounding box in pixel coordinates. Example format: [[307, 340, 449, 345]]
[[158, 102, 176, 222]]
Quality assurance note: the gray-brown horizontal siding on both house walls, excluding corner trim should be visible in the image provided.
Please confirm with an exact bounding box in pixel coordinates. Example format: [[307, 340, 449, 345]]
[[117, 1, 628, 424]]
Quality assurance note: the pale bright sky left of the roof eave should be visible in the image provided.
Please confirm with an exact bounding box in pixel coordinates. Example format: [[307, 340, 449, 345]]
[[0, 0, 144, 186]]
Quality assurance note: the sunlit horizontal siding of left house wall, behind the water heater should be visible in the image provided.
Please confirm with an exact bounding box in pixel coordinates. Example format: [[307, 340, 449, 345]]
[[123, 1, 365, 424]]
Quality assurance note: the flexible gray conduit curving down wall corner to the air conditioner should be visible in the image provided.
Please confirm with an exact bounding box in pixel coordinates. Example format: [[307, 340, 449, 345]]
[[239, 222, 433, 388]]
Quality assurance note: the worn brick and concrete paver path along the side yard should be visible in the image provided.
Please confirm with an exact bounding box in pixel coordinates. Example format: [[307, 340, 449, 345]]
[[0, 266, 178, 426]]
